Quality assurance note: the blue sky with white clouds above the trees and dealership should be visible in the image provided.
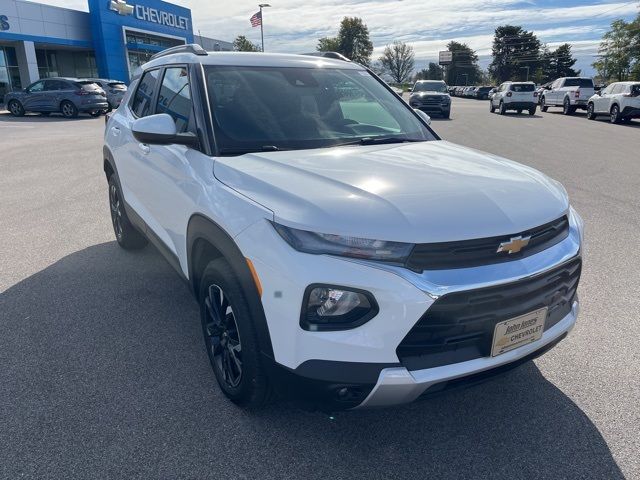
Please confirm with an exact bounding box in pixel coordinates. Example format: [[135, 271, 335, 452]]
[[40, 0, 640, 75]]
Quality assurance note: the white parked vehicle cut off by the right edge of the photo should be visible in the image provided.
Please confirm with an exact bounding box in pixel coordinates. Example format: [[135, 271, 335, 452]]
[[587, 82, 640, 123]]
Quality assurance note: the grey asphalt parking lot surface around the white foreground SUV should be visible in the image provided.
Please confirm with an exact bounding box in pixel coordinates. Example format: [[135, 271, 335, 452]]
[[0, 99, 640, 480]]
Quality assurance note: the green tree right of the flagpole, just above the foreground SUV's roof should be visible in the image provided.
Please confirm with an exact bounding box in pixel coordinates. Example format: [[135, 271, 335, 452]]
[[316, 17, 373, 65]]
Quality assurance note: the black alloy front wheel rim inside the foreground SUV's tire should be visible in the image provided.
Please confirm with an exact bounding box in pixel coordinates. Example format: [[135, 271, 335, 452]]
[[202, 285, 242, 388]]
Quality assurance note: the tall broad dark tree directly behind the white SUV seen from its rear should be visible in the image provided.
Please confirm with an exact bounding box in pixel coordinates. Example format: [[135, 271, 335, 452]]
[[489, 25, 540, 83]]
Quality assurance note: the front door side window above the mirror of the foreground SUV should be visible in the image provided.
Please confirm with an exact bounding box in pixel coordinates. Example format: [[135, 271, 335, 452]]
[[156, 67, 193, 133]]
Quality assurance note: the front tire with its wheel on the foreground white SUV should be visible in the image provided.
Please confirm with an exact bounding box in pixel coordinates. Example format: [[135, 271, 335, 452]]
[[198, 258, 272, 409]]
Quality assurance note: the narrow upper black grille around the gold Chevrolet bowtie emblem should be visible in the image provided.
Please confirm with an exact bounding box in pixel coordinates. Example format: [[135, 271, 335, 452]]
[[406, 215, 569, 272]]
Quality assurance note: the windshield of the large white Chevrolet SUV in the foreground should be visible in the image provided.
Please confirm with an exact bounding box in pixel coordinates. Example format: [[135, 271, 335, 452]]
[[205, 66, 435, 154]]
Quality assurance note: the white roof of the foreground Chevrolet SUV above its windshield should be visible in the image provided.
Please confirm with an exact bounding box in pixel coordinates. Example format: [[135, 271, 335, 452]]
[[136, 52, 365, 75]]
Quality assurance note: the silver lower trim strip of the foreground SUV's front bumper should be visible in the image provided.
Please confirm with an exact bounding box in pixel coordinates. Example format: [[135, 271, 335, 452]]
[[356, 301, 579, 408]]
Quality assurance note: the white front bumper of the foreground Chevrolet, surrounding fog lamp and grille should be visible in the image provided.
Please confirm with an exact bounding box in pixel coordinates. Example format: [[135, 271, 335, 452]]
[[235, 210, 583, 408]]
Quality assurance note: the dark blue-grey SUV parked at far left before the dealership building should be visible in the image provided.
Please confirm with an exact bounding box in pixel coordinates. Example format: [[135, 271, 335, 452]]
[[5, 77, 108, 118]]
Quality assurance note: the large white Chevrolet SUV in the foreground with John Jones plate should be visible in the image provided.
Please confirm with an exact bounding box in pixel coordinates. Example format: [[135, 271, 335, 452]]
[[103, 45, 583, 409]]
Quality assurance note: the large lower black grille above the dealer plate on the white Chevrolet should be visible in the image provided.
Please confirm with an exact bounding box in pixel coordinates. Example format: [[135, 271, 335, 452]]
[[396, 257, 582, 370]]
